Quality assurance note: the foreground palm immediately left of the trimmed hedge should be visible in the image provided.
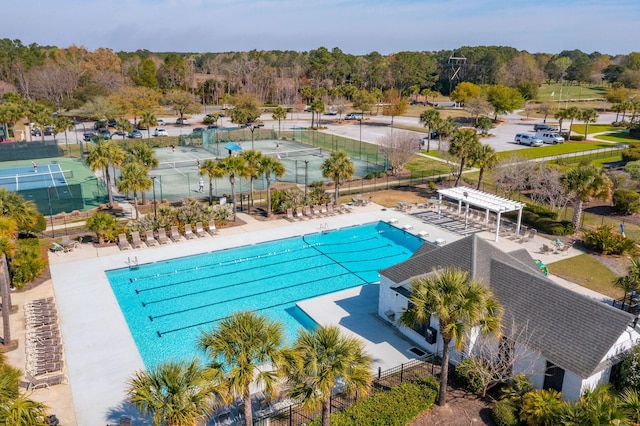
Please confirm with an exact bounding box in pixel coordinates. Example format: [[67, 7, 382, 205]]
[[286, 326, 373, 426]]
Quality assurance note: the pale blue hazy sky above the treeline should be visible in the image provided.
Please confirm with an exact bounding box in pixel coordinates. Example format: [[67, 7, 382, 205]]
[[5, 0, 640, 55]]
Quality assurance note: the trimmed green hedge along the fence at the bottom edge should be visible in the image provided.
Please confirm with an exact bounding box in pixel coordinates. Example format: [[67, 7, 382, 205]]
[[309, 377, 439, 426]]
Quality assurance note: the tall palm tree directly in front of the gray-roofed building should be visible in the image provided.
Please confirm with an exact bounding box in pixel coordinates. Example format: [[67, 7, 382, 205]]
[[400, 267, 502, 406]]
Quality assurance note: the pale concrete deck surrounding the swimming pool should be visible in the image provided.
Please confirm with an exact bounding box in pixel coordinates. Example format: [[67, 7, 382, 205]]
[[7, 204, 602, 425]]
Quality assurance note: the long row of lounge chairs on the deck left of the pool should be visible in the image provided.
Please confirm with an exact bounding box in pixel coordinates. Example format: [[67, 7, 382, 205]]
[[24, 297, 66, 389]]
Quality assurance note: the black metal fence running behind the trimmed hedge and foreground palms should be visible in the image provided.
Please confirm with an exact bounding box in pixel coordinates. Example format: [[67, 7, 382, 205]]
[[253, 354, 441, 426]]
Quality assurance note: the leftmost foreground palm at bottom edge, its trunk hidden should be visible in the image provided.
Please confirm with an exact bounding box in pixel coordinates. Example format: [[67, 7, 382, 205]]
[[127, 359, 226, 426]]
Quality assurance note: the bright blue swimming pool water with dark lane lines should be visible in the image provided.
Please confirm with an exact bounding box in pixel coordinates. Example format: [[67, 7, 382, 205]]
[[107, 222, 422, 367]]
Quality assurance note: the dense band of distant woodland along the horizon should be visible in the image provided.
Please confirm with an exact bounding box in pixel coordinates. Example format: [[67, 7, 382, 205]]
[[0, 38, 640, 110]]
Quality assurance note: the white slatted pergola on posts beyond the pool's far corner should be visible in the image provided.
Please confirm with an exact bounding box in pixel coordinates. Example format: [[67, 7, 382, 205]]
[[438, 186, 525, 241]]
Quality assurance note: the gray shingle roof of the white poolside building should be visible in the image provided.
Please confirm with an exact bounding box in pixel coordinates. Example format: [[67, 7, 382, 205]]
[[380, 236, 634, 378]]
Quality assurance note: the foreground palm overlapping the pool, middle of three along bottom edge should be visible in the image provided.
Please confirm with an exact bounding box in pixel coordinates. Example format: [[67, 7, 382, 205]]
[[198, 312, 285, 426]]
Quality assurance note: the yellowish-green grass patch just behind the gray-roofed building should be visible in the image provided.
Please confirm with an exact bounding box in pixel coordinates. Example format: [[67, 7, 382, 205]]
[[547, 254, 623, 298]]
